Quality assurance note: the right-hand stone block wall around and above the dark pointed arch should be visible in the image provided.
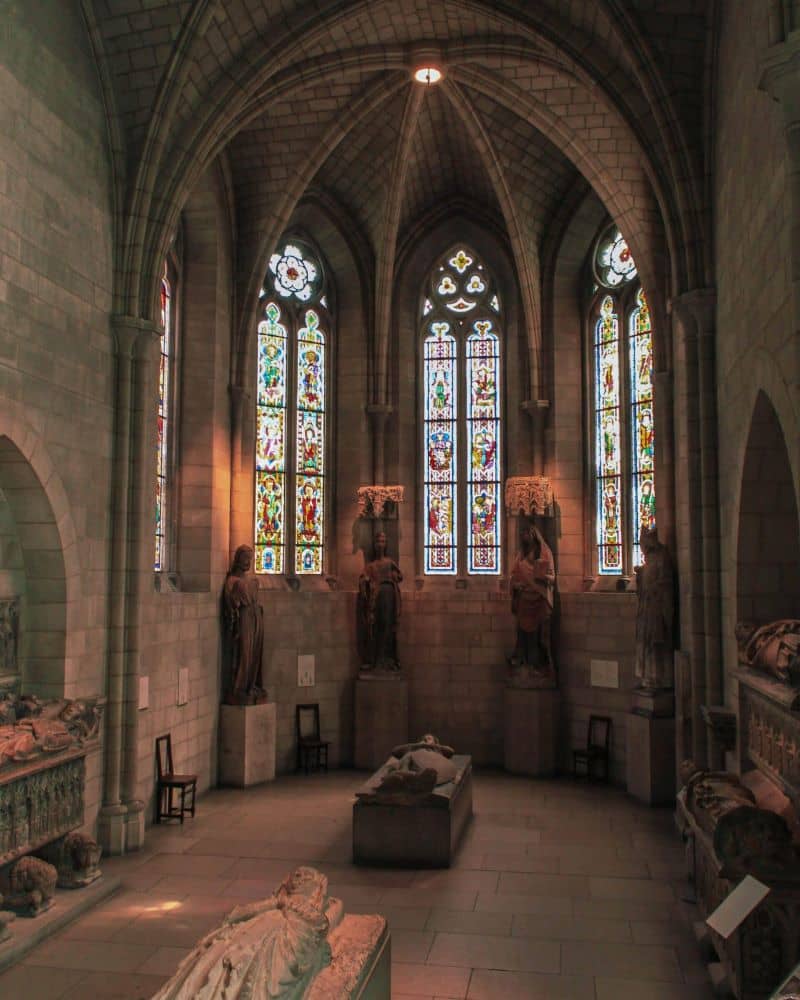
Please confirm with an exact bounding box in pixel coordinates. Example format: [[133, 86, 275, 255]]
[[714, 0, 800, 701]]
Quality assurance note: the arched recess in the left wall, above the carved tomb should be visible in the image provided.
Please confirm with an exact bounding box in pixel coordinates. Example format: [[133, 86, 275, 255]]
[[0, 435, 67, 697]]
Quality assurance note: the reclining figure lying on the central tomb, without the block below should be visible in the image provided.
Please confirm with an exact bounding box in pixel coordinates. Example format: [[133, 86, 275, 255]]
[[356, 733, 458, 805]]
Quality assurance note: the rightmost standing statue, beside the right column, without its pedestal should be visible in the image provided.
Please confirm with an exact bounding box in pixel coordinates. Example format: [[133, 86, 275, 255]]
[[635, 528, 675, 690]]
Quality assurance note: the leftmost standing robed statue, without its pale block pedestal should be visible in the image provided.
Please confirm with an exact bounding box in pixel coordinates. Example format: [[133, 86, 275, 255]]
[[222, 545, 267, 705]]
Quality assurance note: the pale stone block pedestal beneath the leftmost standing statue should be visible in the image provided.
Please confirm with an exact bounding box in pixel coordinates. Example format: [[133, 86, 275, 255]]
[[219, 702, 277, 788]]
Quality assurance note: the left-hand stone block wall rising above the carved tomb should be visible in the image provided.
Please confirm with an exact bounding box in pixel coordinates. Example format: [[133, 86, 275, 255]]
[[0, 0, 114, 827]]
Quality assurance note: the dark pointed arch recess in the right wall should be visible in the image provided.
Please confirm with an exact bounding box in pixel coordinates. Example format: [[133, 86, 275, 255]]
[[736, 390, 800, 624]]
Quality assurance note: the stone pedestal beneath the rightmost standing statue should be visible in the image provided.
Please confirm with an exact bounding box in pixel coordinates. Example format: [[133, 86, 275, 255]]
[[625, 691, 675, 806]]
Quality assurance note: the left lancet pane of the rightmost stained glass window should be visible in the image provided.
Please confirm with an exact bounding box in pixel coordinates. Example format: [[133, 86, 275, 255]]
[[594, 295, 622, 573]]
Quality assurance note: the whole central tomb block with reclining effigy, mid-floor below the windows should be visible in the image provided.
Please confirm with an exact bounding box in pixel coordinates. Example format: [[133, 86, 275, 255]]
[[353, 735, 472, 868]]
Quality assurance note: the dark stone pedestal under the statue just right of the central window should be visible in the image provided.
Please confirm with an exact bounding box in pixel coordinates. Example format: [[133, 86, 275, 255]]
[[503, 687, 560, 777]]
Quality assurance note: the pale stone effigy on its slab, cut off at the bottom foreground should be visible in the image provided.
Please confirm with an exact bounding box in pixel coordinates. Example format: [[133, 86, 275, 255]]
[[153, 867, 391, 1000]]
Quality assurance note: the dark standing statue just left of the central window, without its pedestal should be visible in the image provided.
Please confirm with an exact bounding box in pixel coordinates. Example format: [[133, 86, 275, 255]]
[[357, 531, 403, 670]]
